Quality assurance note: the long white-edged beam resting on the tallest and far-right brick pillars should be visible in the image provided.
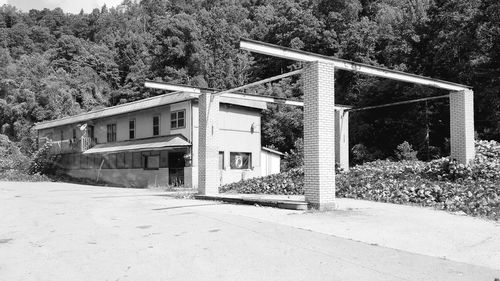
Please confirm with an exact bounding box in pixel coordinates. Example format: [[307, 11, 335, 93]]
[[240, 38, 472, 91]]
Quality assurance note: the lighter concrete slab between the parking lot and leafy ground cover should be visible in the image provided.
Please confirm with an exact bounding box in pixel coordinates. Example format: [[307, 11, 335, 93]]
[[207, 196, 500, 269]]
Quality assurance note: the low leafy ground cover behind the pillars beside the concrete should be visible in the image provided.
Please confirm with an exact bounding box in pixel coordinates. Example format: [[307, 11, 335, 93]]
[[220, 141, 500, 220]]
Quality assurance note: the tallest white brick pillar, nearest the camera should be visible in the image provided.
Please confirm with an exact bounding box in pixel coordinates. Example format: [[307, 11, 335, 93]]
[[302, 62, 335, 210]]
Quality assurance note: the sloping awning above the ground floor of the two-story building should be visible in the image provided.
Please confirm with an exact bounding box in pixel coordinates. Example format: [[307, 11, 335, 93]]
[[83, 135, 191, 154]]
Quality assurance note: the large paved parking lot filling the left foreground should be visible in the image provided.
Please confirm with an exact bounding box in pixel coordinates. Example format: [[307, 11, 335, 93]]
[[0, 179, 500, 281]]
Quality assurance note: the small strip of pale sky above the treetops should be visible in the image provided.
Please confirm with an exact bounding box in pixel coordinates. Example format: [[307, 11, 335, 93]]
[[0, 0, 122, 14]]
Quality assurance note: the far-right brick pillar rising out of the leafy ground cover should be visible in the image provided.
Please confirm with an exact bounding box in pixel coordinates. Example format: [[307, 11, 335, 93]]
[[450, 90, 476, 164]]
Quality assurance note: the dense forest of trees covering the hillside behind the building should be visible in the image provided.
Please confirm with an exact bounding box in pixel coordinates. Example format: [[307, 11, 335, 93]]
[[0, 0, 500, 161]]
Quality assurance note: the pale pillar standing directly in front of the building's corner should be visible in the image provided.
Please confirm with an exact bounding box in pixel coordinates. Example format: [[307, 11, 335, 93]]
[[198, 93, 219, 195]]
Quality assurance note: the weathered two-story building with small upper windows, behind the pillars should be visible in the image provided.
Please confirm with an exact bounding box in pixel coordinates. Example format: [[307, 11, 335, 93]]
[[35, 89, 286, 187]]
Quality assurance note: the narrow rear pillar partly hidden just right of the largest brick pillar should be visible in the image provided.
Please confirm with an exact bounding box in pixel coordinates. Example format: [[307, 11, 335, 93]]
[[335, 108, 349, 171]]
